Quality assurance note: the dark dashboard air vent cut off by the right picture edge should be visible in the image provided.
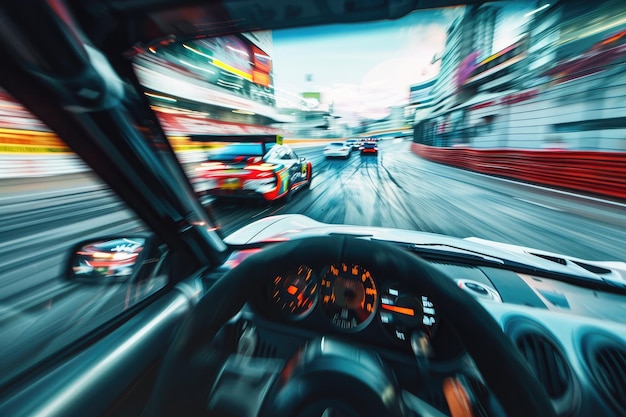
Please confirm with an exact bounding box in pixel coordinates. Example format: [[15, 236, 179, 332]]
[[588, 343, 626, 415]]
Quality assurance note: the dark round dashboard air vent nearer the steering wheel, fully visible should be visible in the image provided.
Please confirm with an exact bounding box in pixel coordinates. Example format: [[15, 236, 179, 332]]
[[515, 332, 572, 400]]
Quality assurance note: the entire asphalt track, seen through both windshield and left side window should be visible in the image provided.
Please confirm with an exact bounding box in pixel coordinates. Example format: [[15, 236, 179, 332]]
[[0, 140, 626, 383]]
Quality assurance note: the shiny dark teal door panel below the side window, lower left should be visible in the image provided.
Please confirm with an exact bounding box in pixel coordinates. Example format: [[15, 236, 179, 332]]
[[0, 276, 202, 417]]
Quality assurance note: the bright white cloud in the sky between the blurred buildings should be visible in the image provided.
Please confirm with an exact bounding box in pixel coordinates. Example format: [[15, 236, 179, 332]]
[[275, 13, 462, 118]]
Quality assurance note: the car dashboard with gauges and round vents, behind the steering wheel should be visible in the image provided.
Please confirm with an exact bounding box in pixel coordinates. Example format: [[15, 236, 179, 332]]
[[208, 244, 626, 416]]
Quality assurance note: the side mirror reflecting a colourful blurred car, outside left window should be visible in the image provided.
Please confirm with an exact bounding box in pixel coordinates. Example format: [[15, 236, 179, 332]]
[[66, 236, 162, 284]]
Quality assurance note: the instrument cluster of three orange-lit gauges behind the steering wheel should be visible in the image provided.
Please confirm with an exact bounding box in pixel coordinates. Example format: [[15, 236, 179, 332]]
[[269, 263, 439, 349]]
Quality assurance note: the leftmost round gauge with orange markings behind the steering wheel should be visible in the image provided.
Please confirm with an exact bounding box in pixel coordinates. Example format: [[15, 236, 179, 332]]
[[270, 265, 319, 319]]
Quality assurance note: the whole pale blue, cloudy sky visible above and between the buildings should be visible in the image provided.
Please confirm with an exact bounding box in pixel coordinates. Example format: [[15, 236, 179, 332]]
[[272, 2, 529, 122]]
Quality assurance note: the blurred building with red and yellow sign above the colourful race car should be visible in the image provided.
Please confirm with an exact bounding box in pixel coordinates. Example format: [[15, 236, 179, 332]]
[[135, 31, 316, 139]]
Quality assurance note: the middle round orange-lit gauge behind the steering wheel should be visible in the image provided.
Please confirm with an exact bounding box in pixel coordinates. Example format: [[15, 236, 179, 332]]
[[320, 264, 378, 330]]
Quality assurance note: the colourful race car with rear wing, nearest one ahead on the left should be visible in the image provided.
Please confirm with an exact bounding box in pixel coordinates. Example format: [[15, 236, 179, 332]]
[[188, 135, 313, 201]]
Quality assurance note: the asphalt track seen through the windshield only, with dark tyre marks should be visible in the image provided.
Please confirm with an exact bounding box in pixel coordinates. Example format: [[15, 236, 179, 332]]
[[215, 140, 626, 261]]
